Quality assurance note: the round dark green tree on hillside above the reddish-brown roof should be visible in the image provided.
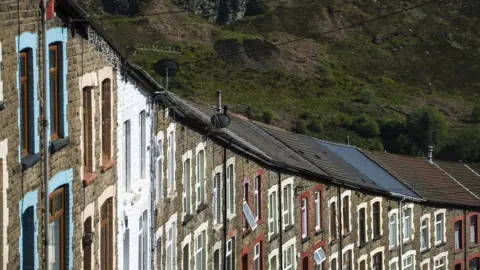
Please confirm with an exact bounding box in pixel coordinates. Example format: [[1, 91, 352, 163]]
[[407, 106, 448, 155]]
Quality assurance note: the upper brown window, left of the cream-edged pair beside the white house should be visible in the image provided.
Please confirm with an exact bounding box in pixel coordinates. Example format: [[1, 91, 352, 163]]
[[83, 87, 94, 172]]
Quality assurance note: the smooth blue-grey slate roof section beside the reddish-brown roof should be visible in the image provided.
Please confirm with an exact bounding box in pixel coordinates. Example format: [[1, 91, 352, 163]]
[[319, 141, 422, 199]]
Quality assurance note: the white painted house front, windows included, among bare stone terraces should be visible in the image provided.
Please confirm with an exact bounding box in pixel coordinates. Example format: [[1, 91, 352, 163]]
[[117, 73, 152, 270]]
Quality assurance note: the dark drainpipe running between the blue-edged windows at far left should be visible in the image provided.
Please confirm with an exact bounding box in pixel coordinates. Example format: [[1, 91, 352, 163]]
[[41, 0, 50, 270]]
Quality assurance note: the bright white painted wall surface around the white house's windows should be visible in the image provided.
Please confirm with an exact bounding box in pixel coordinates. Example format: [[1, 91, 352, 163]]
[[117, 73, 153, 270]]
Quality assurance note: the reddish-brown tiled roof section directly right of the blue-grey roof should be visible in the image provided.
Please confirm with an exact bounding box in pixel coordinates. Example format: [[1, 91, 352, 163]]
[[362, 150, 480, 207]]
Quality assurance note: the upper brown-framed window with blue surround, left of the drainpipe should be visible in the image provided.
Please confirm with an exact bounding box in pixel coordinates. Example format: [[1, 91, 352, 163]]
[[18, 49, 35, 157]]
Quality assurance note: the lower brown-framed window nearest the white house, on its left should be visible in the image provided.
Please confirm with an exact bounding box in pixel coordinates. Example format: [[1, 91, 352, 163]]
[[100, 198, 114, 270]]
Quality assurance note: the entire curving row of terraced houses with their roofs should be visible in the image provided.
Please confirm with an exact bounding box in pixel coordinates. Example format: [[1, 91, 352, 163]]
[[0, 0, 480, 270]]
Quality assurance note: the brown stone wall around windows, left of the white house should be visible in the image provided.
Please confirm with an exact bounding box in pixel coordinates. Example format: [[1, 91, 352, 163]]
[[0, 0, 116, 269]]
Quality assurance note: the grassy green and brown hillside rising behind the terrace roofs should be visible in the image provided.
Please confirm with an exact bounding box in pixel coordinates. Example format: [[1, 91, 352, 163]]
[[86, 0, 480, 160]]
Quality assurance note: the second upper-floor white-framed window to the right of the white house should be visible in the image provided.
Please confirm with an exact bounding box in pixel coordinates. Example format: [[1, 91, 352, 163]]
[[167, 123, 177, 198]]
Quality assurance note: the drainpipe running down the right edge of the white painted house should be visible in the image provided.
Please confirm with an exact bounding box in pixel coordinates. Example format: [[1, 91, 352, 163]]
[[150, 97, 157, 270]]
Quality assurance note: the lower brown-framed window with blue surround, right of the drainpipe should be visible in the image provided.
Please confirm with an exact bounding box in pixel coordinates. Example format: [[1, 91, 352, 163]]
[[48, 187, 68, 270]]
